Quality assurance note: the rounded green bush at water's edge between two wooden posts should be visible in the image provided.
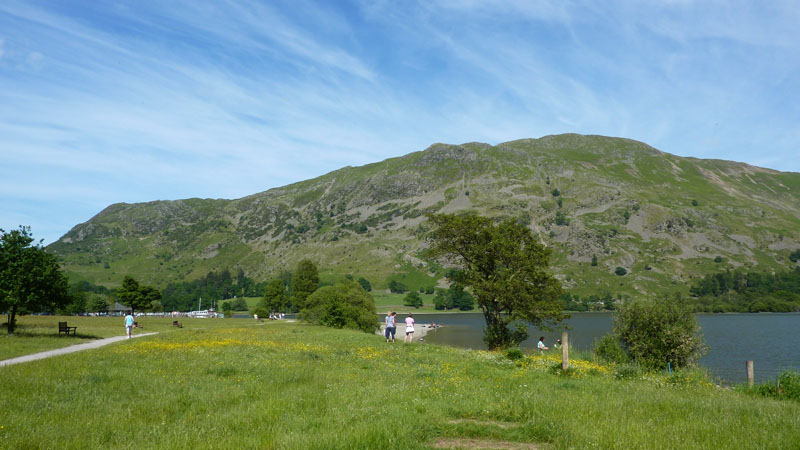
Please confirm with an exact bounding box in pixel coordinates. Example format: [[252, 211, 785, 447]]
[[613, 300, 706, 369]]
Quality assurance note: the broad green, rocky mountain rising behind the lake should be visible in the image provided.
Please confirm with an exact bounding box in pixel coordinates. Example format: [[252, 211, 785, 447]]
[[48, 134, 800, 295]]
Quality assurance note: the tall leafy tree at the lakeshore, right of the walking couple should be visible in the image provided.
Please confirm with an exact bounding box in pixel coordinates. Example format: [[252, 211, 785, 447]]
[[428, 214, 565, 349]]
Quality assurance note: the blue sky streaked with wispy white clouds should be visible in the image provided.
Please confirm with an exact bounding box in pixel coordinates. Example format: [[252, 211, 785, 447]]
[[0, 0, 800, 243]]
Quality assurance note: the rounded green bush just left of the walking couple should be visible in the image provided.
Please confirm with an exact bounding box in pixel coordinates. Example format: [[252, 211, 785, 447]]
[[300, 281, 378, 333]]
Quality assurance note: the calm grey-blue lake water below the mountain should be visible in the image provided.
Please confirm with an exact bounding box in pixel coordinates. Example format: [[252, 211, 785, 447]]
[[406, 313, 800, 383]]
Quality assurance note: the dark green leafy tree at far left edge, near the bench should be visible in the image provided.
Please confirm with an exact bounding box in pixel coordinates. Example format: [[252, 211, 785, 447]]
[[0, 227, 71, 334]]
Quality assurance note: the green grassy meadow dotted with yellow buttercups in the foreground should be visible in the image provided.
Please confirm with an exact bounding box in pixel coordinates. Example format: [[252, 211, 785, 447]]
[[0, 318, 800, 449]]
